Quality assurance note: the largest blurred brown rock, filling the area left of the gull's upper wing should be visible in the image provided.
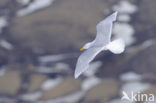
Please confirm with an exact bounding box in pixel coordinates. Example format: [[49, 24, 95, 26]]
[[9, 0, 116, 53]]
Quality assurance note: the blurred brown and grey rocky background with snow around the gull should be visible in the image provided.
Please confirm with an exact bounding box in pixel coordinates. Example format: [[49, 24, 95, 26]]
[[0, 0, 156, 103]]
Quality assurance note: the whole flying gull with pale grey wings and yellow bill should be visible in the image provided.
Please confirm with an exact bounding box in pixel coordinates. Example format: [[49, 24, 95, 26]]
[[74, 12, 125, 78]]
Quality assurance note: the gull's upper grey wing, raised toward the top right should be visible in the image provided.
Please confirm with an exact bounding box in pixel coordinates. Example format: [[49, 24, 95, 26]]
[[94, 12, 117, 45]]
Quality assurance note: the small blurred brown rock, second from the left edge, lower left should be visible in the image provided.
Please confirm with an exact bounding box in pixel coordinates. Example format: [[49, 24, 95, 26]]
[[28, 74, 48, 92]]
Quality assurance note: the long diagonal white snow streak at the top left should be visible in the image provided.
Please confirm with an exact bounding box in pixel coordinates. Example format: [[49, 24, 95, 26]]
[[17, 0, 54, 16]]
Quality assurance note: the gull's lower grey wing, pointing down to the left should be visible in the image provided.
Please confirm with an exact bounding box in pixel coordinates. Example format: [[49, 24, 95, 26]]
[[75, 47, 102, 78]]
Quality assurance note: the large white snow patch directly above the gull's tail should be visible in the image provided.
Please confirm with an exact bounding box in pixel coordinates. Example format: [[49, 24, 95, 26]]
[[113, 23, 135, 45]]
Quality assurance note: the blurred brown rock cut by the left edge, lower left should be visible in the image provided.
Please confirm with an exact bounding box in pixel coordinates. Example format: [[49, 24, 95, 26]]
[[0, 71, 21, 95]]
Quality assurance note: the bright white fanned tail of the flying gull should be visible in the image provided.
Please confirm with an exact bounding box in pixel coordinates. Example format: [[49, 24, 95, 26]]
[[106, 39, 125, 54]]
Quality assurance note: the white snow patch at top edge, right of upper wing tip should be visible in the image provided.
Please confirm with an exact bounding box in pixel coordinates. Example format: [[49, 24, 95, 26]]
[[113, 1, 137, 14]]
